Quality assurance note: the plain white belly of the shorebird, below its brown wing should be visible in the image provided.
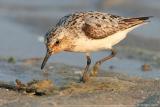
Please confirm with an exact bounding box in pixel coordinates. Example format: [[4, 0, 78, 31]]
[[71, 26, 144, 52]]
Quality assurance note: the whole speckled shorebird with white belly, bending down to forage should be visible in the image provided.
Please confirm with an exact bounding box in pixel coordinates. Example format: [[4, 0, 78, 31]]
[[41, 11, 150, 82]]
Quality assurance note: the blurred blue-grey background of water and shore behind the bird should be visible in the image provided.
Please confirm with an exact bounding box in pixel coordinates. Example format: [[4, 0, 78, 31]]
[[0, 0, 160, 77]]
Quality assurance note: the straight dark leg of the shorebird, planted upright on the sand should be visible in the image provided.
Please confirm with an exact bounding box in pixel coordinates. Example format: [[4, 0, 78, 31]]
[[81, 54, 91, 82]]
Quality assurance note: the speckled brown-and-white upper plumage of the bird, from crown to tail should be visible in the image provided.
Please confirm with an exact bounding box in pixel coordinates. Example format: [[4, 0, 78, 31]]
[[45, 12, 150, 52]]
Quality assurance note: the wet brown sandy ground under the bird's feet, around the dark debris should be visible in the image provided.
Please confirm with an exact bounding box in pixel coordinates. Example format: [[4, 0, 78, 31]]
[[0, 59, 160, 107]]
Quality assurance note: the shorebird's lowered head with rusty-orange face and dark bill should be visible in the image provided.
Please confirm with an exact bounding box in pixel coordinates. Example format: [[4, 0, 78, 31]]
[[41, 28, 71, 69]]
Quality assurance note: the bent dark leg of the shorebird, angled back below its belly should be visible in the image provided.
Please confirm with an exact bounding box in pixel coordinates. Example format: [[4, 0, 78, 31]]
[[91, 49, 117, 76]]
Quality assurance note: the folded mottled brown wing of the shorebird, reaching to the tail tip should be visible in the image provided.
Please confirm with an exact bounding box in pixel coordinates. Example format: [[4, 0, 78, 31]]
[[82, 15, 149, 39]]
